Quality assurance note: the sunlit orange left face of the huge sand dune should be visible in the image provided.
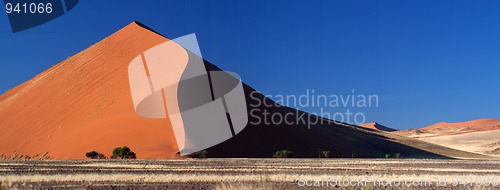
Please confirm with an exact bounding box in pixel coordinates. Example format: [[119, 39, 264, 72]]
[[0, 22, 178, 159]]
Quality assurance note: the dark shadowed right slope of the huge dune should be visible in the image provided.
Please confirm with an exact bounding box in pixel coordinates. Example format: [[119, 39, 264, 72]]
[[205, 61, 491, 159]]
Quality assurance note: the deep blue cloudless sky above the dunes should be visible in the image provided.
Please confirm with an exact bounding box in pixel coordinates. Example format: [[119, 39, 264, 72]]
[[0, 0, 500, 129]]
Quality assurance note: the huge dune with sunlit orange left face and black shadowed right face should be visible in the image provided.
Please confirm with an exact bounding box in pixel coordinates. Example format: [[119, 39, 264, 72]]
[[0, 22, 491, 159]]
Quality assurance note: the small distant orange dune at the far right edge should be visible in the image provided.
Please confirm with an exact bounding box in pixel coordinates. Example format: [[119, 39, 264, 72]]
[[421, 119, 500, 134]]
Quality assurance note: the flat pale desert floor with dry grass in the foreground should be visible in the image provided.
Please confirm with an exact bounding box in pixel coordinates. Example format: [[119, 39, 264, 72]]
[[0, 158, 500, 189]]
